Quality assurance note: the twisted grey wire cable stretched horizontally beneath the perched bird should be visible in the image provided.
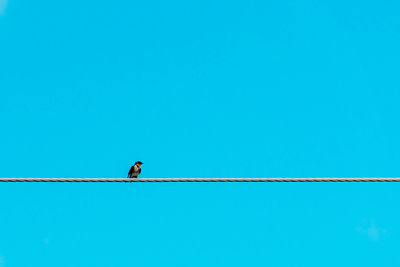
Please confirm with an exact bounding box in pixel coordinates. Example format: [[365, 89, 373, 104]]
[[0, 177, 400, 183]]
